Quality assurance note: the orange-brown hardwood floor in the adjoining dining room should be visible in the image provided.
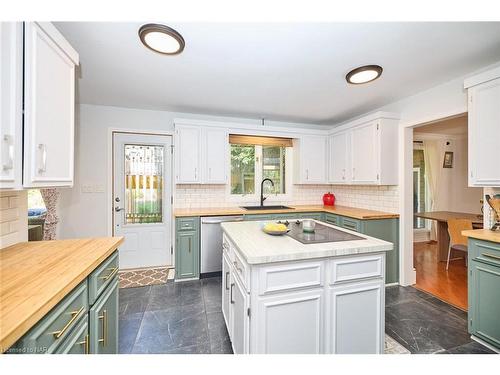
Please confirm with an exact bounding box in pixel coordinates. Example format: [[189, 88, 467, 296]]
[[413, 242, 467, 310]]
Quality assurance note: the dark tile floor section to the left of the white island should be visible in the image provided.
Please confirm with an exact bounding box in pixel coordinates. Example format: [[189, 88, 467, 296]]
[[119, 277, 232, 354]]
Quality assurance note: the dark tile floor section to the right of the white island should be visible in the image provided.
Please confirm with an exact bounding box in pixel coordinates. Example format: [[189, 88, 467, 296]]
[[385, 286, 493, 354]]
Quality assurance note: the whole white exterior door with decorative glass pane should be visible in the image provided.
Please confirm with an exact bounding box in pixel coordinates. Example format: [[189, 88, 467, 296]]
[[111, 133, 172, 269]]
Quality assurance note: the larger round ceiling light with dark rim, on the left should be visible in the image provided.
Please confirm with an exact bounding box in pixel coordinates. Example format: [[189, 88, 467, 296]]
[[139, 23, 185, 55]]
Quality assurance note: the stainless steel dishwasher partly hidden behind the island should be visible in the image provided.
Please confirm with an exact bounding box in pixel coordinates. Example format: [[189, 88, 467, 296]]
[[200, 216, 243, 277]]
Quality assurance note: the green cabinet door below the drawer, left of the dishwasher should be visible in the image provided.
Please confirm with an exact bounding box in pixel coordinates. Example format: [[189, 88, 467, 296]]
[[175, 231, 199, 279]]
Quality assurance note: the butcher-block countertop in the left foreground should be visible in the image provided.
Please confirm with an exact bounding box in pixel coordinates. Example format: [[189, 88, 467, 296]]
[[0, 237, 123, 353]]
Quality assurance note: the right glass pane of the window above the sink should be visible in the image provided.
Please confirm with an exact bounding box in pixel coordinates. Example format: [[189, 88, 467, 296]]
[[262, 146, 286, 194]]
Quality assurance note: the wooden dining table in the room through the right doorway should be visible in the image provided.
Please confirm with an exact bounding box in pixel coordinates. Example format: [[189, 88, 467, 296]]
[[415, 211, 483, 262]]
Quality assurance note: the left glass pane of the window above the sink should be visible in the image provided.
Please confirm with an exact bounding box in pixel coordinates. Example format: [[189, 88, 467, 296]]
[[231, 144, 255, 194]]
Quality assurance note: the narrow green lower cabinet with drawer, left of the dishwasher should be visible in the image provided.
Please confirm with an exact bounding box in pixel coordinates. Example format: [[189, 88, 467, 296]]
[[175, 217, 200, 280]]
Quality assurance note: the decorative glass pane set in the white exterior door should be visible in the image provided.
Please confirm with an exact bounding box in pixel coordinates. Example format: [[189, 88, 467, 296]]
[[124, 145, 164, 224]]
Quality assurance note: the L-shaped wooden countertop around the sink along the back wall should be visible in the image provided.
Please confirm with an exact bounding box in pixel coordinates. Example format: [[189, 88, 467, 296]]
[[174, 205, 399, 220]]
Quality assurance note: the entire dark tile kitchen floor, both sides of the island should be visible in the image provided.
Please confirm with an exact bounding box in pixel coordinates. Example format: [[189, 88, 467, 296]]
[[119, 277, 492, 354]]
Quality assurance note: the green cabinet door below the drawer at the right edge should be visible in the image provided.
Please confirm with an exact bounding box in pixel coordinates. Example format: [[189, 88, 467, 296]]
[[469, 261, 500, 347]]
